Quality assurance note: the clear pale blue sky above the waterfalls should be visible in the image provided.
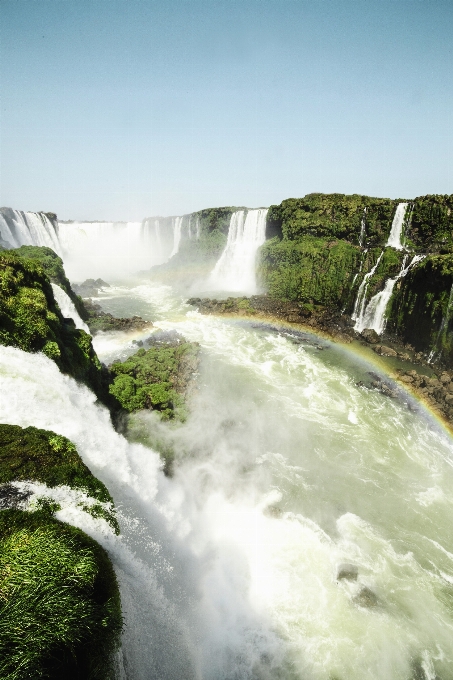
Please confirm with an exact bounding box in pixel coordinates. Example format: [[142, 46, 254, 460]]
[[0, 0, 453, 220]]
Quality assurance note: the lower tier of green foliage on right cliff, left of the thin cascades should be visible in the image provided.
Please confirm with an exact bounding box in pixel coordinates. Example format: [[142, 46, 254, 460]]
[[258, 236, 361, 306]]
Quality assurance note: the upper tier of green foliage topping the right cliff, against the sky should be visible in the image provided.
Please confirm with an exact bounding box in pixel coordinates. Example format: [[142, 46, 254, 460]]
[[267, 194, 398, 246]]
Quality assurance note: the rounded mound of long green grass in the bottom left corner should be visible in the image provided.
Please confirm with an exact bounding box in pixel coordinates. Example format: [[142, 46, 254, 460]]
[[0, 505, 122, 680]]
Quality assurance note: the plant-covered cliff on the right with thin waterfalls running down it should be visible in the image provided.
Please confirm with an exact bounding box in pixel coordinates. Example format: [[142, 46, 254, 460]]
[[257, 194, 453, 364]]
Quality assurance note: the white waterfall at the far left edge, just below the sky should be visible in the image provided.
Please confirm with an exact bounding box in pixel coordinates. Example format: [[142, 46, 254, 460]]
[[0, 208, 61, 255]]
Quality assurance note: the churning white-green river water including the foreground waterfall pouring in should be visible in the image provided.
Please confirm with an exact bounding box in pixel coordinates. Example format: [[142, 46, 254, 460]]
[[0, 281, 453, 680]]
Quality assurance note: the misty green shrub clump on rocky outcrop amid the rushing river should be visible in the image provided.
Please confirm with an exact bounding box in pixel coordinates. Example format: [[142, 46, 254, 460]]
[[110, 342, 198, 419]]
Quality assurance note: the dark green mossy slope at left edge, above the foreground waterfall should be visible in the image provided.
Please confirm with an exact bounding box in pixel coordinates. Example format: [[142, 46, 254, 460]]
[[0, 249, 109, 403]]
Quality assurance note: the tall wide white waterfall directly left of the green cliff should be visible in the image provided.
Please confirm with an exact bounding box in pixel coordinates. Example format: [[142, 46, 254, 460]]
[[210, 208, 268, 293]]
